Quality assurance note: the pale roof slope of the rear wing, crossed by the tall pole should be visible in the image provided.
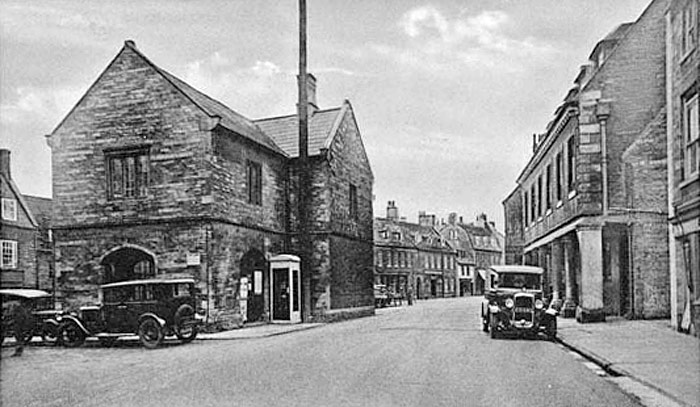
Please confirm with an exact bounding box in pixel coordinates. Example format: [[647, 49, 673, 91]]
[[253, 105, 346, 157]]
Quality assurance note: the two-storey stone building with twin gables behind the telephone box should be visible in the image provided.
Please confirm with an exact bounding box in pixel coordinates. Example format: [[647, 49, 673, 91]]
[[47, 41, 374, 327]]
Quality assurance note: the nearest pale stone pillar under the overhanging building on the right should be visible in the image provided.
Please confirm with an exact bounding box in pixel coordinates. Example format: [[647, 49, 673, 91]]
[[576, 226, 605, 322]]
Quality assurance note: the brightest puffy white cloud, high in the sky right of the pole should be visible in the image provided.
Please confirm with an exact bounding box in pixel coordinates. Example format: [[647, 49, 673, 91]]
[[378, 5, 556, 73]]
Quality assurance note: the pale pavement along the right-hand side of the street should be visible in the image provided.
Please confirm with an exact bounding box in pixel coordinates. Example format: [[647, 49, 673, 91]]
[[557, 318, 700, 407]]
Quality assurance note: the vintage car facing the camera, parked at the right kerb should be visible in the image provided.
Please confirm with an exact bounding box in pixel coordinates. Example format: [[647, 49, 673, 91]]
[[481, 265, 558, 339]]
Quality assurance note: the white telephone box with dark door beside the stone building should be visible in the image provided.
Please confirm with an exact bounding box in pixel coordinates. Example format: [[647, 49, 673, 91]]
[[270, 254, 301, 324]]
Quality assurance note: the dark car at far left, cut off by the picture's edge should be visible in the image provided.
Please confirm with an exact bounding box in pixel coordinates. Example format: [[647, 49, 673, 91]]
[[0, 288, 61, 344]]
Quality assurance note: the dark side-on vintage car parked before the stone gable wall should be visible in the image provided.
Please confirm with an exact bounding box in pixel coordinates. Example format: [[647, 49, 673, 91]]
[[59, 278, 202, 349]]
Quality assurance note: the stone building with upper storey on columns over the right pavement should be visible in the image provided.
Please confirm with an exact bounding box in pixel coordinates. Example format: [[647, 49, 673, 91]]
[[506, 0, 670, 321]]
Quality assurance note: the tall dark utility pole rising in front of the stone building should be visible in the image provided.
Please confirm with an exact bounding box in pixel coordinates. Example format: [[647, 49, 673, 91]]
[[297, 0, 311, 322]]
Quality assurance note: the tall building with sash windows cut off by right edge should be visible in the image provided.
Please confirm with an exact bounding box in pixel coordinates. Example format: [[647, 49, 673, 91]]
[[666, 0, 700, 335]]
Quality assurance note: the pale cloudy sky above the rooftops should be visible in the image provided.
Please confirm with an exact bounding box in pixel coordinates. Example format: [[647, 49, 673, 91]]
[[0, 0, 650, 230]]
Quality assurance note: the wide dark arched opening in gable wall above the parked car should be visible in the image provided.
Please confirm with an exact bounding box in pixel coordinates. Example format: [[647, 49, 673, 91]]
[[100, 246, 156, 284]]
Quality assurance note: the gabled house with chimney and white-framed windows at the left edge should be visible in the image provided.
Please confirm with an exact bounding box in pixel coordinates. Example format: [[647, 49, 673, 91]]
[[0, 149, 53, 291]]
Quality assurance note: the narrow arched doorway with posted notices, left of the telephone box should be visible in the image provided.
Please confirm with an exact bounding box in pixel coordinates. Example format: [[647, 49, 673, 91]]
[[241, 249, 267, 321]]
